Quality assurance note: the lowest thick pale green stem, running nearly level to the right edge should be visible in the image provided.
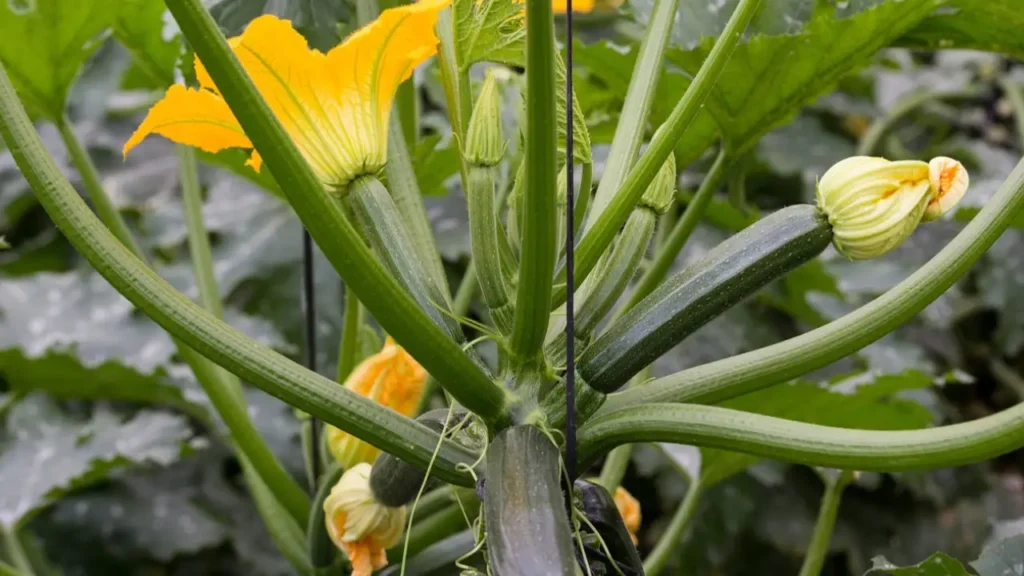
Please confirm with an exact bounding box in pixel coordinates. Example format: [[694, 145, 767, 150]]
[[579, 404, 1024, 471]]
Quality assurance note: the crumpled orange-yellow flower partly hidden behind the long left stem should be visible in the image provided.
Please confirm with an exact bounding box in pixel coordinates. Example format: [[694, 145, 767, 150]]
[[327, 336, 427, 468]]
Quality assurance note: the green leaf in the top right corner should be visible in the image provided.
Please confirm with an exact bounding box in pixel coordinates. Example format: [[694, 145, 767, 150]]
[[897, 0, 1024, 58]]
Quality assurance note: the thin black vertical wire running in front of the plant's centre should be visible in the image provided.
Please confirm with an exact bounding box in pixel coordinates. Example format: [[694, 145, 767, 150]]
[[565, 0, 577, 481]]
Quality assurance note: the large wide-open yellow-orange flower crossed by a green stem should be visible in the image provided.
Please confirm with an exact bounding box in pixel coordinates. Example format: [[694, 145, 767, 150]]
[[124, 0, 451, 192]]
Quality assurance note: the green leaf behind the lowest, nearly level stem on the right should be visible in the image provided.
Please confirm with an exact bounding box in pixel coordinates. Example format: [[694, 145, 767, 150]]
[[701, 371, 932, 485]]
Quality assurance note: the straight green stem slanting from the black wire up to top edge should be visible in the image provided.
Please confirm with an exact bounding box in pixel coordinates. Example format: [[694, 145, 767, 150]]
[[554, 0, 761, 304]]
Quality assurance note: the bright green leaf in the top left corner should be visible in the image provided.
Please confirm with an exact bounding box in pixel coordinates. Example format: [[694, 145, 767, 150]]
[[0, 0, 114, 120]]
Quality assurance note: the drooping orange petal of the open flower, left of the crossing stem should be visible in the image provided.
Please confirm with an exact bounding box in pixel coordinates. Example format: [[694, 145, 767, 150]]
[[124, 84, 253, 155]]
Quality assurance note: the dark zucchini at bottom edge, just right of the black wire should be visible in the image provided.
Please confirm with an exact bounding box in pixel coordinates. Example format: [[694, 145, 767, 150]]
[[575, 480, 644, 576]]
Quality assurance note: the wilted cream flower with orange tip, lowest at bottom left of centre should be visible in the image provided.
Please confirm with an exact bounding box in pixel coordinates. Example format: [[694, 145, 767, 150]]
[[324, 463, 406, 576]]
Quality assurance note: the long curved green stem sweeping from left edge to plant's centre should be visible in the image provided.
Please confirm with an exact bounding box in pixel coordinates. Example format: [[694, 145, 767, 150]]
[[0, 59, 479, 483]]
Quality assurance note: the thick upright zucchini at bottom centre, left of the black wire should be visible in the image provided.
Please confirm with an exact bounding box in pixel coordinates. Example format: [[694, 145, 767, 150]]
[[483, 425, 577, 576]]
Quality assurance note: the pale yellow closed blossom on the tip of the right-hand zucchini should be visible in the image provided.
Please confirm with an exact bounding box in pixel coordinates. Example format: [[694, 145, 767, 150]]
[[817, 156, 969, 259]]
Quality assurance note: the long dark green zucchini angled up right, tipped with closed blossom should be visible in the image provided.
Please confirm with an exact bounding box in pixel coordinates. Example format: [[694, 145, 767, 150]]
[[579, 204, 833, 394]]
